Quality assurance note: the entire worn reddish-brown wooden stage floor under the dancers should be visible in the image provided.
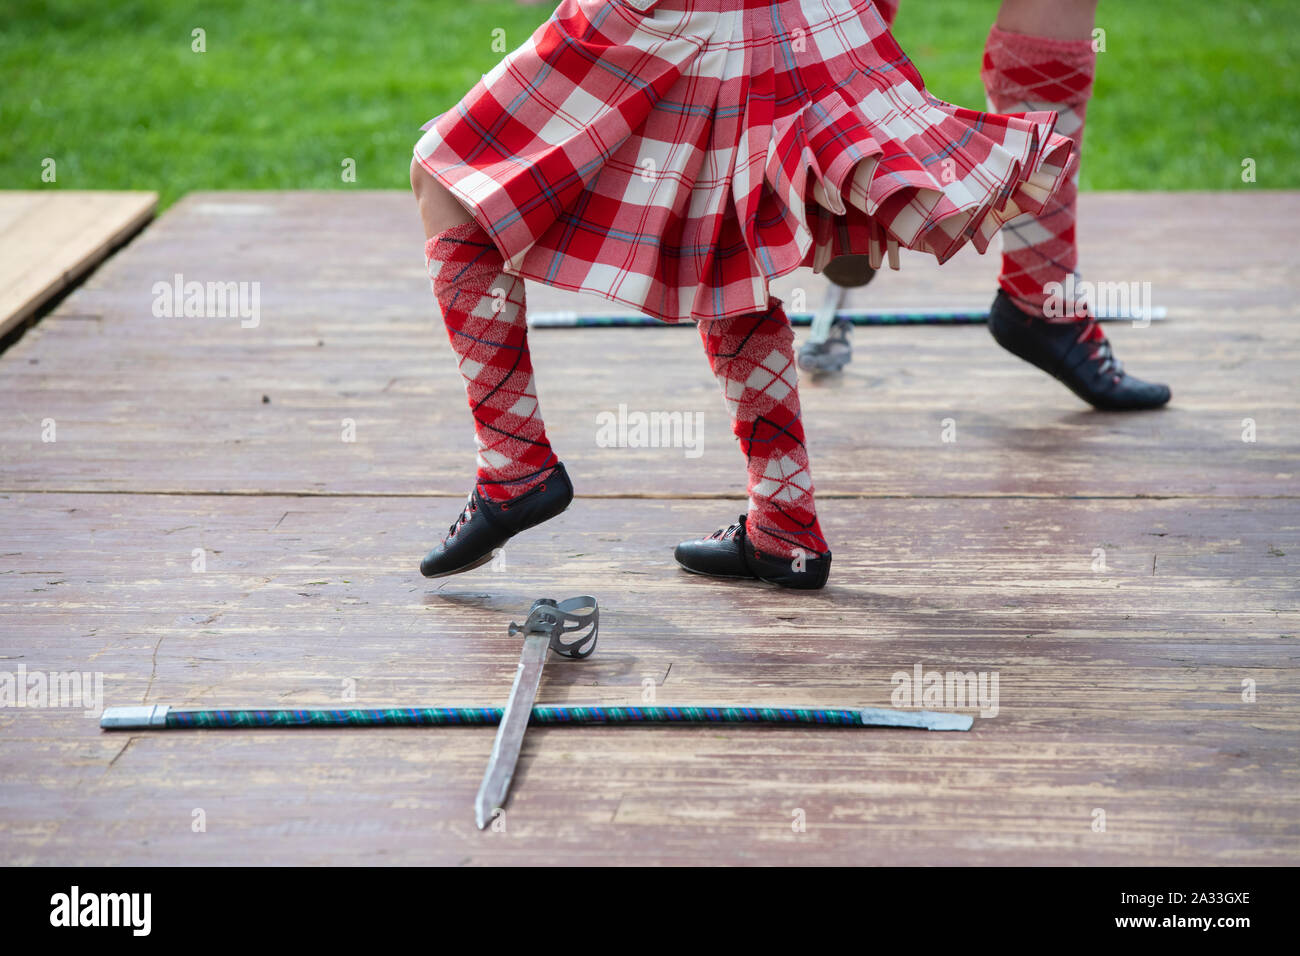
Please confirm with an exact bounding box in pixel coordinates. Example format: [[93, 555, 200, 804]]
[[0, 191, 1300, 865]]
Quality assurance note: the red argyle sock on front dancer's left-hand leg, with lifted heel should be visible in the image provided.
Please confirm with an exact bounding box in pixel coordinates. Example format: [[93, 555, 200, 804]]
[[424, 221, 559, 501]]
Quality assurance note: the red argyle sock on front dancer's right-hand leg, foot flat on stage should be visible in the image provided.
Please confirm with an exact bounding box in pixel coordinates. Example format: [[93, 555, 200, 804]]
[[699, 299, 828, 557]]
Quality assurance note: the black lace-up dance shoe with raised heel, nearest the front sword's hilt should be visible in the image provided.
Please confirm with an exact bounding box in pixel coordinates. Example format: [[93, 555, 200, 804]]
[[420, 464, 573, 578]]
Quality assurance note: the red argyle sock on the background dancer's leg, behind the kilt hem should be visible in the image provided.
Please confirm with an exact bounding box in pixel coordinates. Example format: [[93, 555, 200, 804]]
[[982, 26, 1097, 321]]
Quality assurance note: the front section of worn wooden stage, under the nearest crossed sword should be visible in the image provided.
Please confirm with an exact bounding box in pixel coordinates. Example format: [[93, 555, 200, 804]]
[[0, 494, 1300, 865]]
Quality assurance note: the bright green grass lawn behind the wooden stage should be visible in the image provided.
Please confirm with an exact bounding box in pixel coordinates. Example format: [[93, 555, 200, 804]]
[[0, 0, 1300, 206]]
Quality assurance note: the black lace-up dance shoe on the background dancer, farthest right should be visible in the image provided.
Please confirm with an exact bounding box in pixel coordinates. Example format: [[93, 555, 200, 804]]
[[988, 289, 1170, 411]]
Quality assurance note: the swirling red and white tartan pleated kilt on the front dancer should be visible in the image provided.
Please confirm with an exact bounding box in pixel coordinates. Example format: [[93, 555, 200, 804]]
[[415, 0, 1070, 321]]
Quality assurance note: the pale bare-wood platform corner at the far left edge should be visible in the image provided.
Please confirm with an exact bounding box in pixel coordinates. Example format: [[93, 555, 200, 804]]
[[0, 190, 159, 338]]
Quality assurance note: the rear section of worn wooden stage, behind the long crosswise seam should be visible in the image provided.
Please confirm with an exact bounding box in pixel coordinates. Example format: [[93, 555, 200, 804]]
[[0, 193, 1300, 498]]
